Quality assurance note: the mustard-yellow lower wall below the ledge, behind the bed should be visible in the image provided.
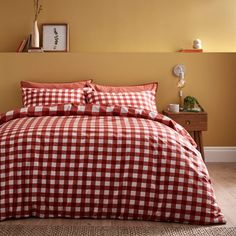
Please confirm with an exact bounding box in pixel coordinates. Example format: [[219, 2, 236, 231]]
[[0, 53, 236, 146]]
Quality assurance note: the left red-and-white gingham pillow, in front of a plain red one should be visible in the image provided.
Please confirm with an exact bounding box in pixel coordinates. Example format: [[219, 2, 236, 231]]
[[22, 88, 85, 107]]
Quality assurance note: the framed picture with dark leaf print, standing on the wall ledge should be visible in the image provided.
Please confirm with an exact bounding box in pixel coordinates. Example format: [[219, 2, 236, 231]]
[[42, 24, 69, 52]]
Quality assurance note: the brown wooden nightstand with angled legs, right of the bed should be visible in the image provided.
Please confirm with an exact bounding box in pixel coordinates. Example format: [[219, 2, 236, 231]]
[[163, 111, 207, 161]]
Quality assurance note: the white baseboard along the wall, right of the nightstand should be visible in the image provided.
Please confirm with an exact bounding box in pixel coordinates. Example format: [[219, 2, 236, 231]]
[[204, 147, 236, 162]]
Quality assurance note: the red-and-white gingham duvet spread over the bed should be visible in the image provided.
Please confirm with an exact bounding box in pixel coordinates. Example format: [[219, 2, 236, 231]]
[[0, 104, 225, 224]]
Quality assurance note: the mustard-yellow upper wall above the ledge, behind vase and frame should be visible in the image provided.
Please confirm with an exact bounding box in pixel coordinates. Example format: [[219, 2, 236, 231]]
[[0, 0, 236, 52]]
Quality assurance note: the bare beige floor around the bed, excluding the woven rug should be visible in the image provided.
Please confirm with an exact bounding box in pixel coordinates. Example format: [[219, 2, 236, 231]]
[[0, 163, 236, 227]]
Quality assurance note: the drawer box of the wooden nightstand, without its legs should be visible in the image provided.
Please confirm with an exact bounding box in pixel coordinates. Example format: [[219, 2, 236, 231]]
[[163, 112, 207, 131]]
